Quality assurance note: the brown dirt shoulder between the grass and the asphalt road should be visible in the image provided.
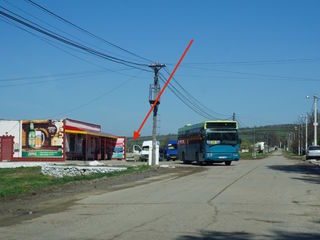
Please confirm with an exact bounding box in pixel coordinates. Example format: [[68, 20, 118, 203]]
[[0, 167, 205, 226]]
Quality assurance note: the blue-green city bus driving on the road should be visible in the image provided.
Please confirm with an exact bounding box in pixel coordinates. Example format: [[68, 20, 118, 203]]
[[178, 120, 241, 166]]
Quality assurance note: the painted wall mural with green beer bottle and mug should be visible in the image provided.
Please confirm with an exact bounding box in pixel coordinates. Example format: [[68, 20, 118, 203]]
[[22, 120, 63, 158]]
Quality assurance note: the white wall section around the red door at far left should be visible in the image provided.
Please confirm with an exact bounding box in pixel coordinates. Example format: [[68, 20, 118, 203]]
[[0, 120, 22, 157]]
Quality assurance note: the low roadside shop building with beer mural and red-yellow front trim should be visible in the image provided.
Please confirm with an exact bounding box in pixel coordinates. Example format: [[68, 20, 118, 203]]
[[0, 118, 126, 161]]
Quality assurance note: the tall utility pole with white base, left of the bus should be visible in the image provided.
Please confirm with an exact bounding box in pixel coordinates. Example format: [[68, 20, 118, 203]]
[[149, 62, 166, 166]]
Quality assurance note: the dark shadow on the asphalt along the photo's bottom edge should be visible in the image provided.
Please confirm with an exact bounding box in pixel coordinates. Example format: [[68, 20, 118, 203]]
[[177, 231, 320, 240]]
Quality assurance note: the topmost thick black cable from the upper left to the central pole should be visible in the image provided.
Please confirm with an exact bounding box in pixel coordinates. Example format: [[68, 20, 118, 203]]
[[26, 0, 153, 62]]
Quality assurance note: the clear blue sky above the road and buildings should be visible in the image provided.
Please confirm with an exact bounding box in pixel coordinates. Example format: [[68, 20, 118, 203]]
[[0, 0, 320, 136]]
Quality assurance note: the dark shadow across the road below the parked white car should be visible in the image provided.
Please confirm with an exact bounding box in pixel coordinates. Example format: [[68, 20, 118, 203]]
[[268, 164, 320, 184]]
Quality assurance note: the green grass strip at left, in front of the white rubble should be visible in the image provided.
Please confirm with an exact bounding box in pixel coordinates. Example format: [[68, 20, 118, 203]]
[[0, 165, 150, 199]]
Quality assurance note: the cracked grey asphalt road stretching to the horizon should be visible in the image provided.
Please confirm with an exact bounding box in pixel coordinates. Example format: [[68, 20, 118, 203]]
[[0, 152, 320, 240]]
